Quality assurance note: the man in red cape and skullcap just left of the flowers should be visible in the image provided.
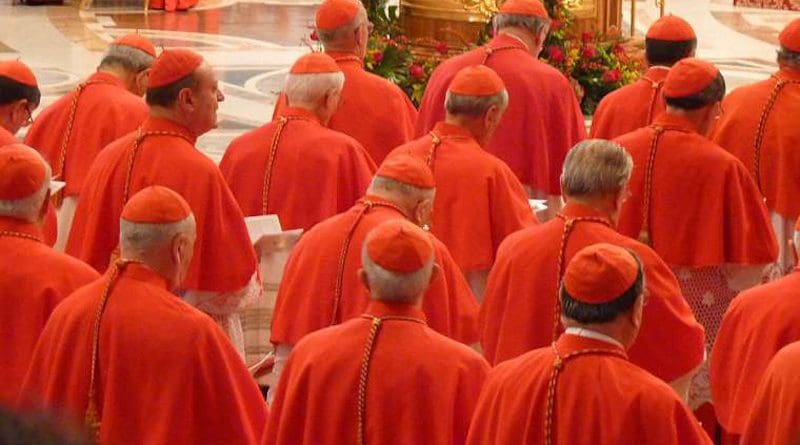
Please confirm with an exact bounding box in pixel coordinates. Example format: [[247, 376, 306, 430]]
[[274, 0, 417, 164]]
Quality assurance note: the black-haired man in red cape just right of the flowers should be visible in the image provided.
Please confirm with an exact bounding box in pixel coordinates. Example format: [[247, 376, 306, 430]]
[[589, 15, 697, 139]]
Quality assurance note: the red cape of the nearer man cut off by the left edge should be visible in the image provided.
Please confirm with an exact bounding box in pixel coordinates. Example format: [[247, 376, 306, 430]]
[[0, 217, 98, 405]]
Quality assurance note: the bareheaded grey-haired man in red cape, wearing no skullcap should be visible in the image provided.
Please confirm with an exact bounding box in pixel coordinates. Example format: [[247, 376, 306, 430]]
[[481, 140, 705, 397]]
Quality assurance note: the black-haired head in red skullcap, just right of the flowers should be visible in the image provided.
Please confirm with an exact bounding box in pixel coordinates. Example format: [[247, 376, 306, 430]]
[[645, 15, 697, 67]]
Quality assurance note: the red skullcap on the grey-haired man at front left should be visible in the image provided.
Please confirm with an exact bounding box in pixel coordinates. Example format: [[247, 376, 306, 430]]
[[121, 185, 192, 224]]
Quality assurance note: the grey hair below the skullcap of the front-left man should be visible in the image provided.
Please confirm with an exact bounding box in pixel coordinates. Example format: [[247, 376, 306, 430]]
[[119, 215, 195, 255]]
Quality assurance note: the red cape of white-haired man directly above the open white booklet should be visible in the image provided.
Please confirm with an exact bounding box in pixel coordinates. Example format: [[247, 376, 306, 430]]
[[219, 108, 375, 230]]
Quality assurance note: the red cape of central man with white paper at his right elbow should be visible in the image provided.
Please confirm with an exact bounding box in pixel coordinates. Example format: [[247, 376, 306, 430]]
[[390, 122, 537, 272]]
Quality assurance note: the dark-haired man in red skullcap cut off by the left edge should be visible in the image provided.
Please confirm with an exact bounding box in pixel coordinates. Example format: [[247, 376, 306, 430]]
[[0, 60, 58, 246]]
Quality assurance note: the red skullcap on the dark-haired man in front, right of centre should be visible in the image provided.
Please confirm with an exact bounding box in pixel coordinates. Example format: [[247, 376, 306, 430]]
[[564, 243, 639, 304]]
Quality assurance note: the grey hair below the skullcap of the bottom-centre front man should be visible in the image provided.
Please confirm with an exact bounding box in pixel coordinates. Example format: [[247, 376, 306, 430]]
[[361, 243, 434, 303]]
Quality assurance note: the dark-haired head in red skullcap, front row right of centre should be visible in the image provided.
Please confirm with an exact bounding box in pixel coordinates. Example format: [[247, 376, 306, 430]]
[[560, 243, 644, 325]]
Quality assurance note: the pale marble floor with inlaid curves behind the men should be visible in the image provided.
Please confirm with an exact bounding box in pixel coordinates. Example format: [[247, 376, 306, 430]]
[[0, 0, 800, 160]]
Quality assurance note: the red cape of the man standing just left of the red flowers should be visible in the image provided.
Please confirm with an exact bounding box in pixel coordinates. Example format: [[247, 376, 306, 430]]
[[274, 51, 417, 165]]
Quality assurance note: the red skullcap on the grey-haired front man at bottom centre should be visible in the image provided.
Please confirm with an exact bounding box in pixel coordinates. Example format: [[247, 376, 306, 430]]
[[364, 219, 433, 274]]
